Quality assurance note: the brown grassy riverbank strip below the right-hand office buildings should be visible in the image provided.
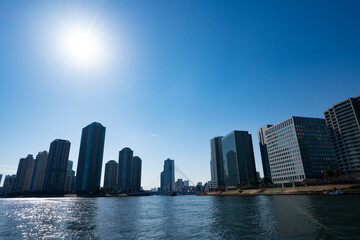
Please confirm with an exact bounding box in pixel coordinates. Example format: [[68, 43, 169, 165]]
[[206, 184, 360, 196]]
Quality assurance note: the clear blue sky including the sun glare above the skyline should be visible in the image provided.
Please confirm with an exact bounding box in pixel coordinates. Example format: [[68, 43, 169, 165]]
[[0, 0, 360, 189]]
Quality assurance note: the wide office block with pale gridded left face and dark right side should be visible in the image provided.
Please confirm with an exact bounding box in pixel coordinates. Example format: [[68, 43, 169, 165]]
[[265, 117, 335, 183]]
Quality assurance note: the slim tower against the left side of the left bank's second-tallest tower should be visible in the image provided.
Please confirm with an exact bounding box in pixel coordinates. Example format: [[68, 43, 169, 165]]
[[30, 151, 48, 192]]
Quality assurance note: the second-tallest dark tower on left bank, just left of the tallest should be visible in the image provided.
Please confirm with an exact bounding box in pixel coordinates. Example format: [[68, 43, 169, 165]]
[[43, 139, 70, 193]]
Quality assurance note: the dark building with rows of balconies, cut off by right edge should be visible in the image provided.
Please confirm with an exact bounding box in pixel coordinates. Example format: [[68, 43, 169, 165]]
[[324, 94, 360, 174]]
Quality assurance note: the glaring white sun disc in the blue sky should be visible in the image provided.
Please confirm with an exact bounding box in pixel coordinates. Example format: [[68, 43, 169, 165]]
[[60, 23, 104, 68]]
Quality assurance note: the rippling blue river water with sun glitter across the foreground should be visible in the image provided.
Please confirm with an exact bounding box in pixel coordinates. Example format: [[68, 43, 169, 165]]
[[0, 195, 360, 239]]
